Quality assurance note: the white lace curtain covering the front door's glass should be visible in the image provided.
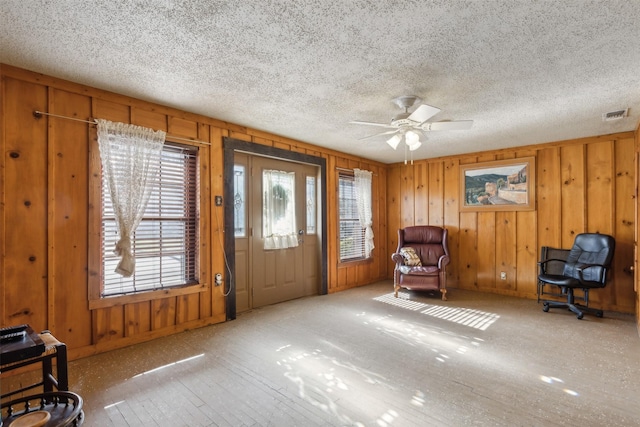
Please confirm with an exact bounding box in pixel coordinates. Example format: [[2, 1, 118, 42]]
[[262, 170, 298, 249]]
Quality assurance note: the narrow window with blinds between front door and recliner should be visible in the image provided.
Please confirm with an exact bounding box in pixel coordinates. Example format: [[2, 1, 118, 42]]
[[338, 173, 365, 262]]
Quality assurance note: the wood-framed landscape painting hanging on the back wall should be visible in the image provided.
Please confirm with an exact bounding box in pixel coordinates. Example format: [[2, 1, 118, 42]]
[[460, 157, 536, 212]]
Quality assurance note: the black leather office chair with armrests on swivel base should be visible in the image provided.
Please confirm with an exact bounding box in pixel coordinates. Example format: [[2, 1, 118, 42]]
[[538, 233, 616, 319]]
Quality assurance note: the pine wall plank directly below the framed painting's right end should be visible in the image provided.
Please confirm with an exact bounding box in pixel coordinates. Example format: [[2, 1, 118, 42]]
[[507, 211, 538, 298]]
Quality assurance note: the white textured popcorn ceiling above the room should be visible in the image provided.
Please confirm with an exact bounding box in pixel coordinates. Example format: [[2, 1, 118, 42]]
[[0, 0, 640, 163]]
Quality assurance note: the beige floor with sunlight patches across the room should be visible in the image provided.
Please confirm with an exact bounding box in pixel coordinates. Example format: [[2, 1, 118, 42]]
[[3, 282, 640, 427]]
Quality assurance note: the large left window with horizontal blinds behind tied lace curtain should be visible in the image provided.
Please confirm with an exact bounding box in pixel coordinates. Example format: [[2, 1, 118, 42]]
[[100, 143, 199, 297]]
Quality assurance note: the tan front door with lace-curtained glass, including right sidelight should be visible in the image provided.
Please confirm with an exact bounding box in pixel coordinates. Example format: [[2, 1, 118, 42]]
[[236, 155, 321, 312]]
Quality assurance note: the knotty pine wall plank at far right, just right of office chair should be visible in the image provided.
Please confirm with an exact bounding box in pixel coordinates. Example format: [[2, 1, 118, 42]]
[[612, 138, 636, 313]]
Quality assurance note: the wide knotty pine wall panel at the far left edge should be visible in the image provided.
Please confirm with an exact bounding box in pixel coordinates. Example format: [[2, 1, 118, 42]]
[[0, 77, 48, 330]]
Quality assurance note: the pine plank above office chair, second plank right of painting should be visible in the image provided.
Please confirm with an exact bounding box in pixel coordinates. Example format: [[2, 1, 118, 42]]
[[560, 144, 588, 248]]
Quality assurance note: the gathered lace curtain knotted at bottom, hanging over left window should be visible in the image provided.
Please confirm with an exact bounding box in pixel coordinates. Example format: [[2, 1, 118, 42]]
[[96, 119, 166, 277]]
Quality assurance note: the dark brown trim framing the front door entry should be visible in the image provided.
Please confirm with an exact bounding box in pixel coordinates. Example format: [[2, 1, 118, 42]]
[[222, 137, 328, 320]]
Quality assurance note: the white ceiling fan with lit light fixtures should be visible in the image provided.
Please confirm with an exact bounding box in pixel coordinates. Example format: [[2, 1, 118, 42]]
[[349, 95, 473, 163]]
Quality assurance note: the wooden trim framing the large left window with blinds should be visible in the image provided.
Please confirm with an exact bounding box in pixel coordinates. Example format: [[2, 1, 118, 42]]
[[87, 135, 212, 310]]
